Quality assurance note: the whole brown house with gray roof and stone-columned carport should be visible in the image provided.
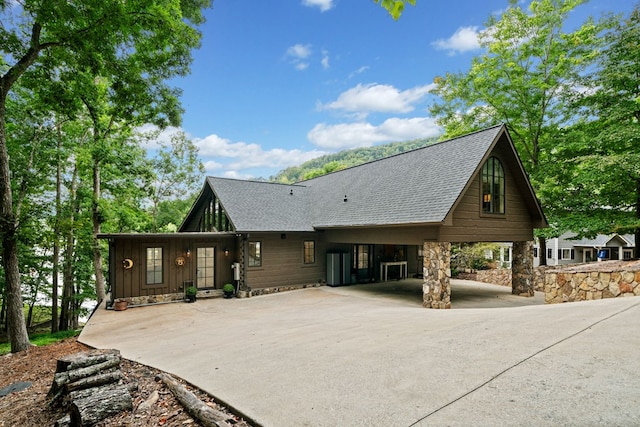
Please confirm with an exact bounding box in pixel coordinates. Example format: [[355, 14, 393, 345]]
[[100, 126, 547, 308]]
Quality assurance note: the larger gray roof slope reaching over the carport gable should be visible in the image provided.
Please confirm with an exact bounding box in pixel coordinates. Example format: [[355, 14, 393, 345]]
[[301, 126, 502, 228]]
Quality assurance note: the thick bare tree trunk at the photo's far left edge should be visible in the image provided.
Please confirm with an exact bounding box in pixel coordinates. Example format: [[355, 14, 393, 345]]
[[0, 98, 31, 353]]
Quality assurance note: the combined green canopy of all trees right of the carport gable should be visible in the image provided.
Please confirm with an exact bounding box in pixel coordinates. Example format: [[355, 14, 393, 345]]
[[424, 0, 638, 254]]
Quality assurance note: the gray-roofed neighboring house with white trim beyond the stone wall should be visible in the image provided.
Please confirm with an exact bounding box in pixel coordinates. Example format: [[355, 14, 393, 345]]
[[533, 232, 636, 267]]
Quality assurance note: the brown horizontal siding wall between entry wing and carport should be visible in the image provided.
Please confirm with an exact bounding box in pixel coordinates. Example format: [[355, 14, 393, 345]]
[[246, 233, 326, 289]]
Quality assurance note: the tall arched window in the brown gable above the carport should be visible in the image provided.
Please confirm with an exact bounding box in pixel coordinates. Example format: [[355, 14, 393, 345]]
[[480, 156, 507, 218]]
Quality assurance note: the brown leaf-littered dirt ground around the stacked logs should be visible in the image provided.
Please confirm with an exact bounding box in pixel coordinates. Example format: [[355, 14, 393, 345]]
[[0, 338, 250, 427]]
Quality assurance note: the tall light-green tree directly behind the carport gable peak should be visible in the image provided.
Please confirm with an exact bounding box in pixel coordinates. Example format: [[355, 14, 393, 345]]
[[431, 0, 607, 260]]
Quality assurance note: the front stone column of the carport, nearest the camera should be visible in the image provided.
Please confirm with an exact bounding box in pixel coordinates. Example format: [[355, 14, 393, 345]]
[[422, 242, 451, 308]]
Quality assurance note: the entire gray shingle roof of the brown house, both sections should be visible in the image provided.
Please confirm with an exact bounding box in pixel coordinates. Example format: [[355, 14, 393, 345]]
[[208, 126, 528, 232]]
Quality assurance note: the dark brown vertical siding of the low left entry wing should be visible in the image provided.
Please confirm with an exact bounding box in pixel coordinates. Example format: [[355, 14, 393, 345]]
[[109, 235, 238, 298]]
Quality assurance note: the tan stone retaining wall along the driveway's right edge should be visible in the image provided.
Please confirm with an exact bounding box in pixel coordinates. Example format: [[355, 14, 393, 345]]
[[544, 261, 640, 304]]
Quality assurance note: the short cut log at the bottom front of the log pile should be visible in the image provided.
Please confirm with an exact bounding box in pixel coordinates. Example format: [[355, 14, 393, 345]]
[[70, 385, 133, 426]]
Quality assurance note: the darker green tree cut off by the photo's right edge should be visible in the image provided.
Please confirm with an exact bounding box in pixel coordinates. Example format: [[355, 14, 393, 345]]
[[558, 3, 640, 257]]
